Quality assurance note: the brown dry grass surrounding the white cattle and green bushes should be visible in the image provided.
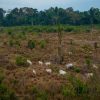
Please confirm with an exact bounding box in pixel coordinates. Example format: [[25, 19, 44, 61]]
[[0, 29, 100, 100]]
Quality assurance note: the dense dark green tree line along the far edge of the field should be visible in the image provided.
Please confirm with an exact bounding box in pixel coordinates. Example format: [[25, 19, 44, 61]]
[[0, 7, 100, 26]]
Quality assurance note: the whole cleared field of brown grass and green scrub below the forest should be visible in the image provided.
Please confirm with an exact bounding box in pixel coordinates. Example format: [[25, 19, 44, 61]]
[[0, 25, 100, 100]]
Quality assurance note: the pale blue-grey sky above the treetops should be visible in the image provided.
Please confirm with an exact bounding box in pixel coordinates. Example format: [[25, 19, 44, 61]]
[[0, 0, 100, 11]]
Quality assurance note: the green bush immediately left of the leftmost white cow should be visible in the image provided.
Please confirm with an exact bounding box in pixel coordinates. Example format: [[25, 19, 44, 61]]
[[16, 56, 28, 67]]
